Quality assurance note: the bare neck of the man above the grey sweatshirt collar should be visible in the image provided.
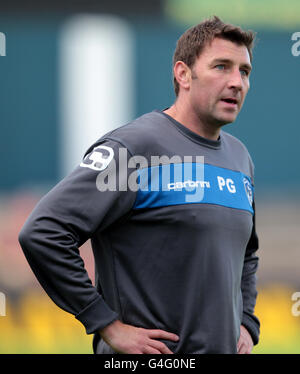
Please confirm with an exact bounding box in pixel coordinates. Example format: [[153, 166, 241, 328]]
[[164, 102, 220, 140]]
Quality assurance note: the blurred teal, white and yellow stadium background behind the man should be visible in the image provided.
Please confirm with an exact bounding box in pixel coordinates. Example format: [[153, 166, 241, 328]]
[[0, 0, 300, 353]]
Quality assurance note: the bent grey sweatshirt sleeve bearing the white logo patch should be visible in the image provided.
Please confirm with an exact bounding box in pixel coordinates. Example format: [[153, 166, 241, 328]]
[[19, 140, 135, 334]]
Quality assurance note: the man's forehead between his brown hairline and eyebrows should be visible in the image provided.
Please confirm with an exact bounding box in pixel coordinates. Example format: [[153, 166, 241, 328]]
[[197, 38, 250, 65]]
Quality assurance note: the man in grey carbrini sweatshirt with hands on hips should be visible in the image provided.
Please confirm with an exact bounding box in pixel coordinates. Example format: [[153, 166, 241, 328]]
[[19, 17, 259, 354]]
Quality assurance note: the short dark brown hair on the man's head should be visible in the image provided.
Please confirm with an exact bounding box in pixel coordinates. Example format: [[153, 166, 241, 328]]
[[173, 16, 255, 96]]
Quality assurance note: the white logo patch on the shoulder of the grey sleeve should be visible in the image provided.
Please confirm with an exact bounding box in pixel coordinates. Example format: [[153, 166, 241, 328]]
[[80, 145, 114, 171]]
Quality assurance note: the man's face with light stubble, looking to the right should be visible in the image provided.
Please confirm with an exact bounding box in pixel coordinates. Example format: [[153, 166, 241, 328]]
[[188, 38, 251, 126]]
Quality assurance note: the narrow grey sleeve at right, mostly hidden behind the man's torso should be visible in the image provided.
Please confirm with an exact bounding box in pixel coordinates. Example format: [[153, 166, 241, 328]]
[[241, 197, 260, 345]]
